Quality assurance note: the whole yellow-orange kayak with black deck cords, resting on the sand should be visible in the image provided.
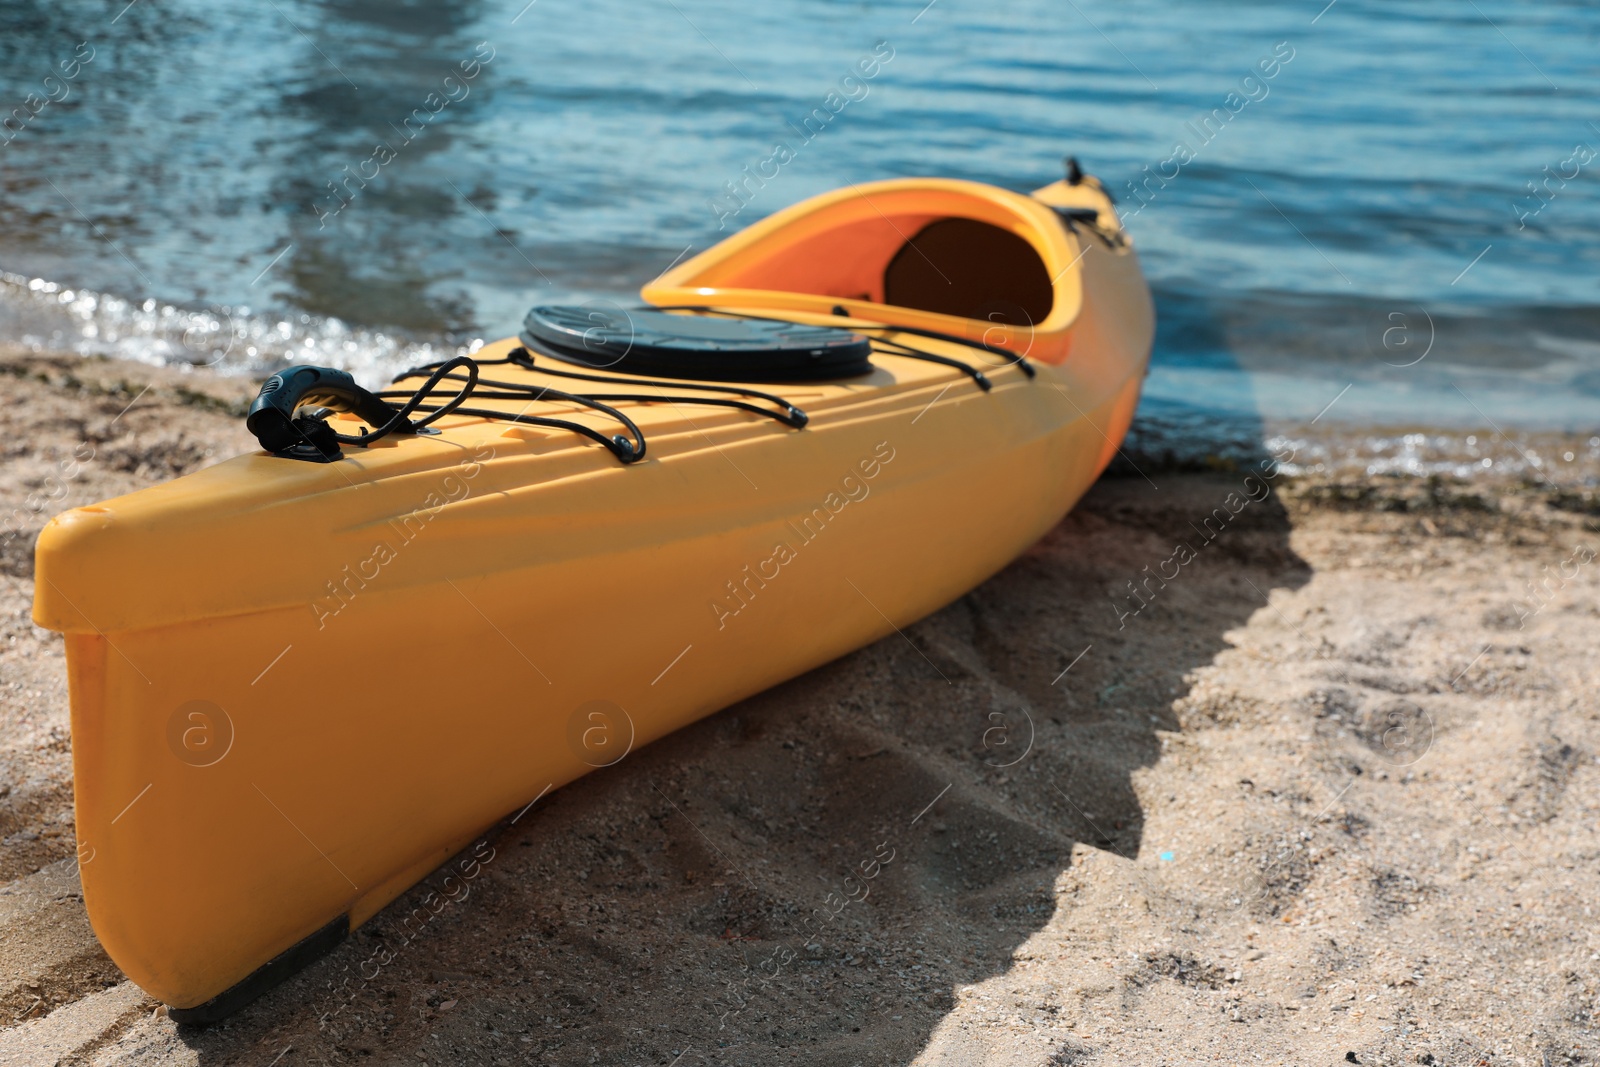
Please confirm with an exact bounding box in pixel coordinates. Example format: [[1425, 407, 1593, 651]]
[[34, 168, 1154, 1022]]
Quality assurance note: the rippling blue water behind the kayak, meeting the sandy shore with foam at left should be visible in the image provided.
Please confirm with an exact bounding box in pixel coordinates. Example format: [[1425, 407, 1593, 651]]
[[0, 0, 1600, 432]]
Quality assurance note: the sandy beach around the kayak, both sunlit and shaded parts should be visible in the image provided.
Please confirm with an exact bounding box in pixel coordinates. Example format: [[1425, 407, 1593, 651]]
[[0, 352, 1600, 1067]]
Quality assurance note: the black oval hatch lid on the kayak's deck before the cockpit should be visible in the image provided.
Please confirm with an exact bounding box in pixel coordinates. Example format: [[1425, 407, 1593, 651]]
[[522, 306, 872, 382]]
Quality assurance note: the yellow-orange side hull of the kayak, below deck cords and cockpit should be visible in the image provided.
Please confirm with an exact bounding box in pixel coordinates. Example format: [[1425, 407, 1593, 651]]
[[35, 171, 1150, 1019]]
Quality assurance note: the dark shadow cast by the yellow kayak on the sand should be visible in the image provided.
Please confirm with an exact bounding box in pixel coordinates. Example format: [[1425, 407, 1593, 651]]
[[168, 415, 1309, 1065]]
